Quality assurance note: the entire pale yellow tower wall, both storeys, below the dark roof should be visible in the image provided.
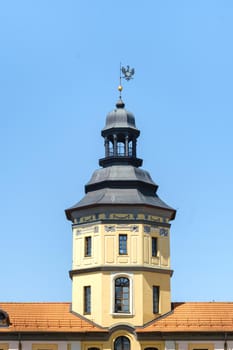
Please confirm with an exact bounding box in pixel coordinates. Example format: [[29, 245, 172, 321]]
[[71, 213, 171, 327]]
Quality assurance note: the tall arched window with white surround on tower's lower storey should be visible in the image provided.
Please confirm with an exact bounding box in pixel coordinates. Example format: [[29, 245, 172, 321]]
[[114, 277, 130, 314]]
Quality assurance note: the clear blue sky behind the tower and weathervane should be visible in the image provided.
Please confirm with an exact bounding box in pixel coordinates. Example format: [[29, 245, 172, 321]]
[[0, 0, 233, 301]]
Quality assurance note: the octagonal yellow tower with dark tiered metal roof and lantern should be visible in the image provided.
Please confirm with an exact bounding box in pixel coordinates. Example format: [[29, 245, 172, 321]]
[[66, 92, 175, 327]]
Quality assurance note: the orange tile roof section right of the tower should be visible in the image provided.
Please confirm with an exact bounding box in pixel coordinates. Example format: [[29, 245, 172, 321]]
[[137, 302, 233, 332]]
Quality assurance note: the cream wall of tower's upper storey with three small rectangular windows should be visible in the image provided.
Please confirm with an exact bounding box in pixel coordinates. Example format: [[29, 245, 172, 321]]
[[72, 224, 170, 270]]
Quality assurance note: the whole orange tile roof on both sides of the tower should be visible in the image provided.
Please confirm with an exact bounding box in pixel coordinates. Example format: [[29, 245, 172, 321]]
[[0, 302, 233, 334]]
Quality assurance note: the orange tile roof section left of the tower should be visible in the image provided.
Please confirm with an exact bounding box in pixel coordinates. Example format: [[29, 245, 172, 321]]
[[0, 302, 103, 334]]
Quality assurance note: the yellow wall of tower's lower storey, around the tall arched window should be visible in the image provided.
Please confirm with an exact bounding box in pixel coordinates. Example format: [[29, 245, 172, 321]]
[[72, 269, 171, 327]]
